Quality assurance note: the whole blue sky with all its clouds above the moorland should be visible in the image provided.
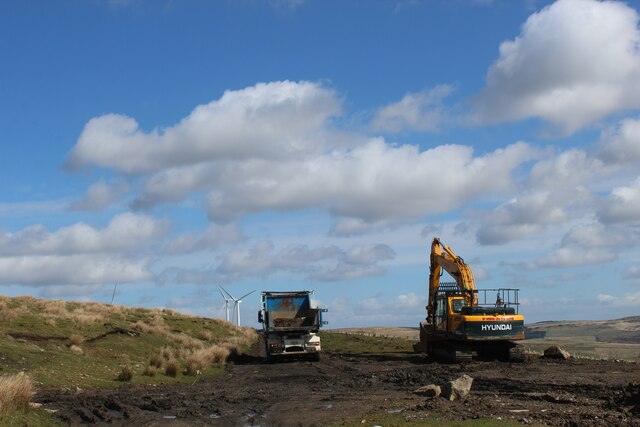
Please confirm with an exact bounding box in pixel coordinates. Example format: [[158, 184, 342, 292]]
[[0, 0, 640, 327]]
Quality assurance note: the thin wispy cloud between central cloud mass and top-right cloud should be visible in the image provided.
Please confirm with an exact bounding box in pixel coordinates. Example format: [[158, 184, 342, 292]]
[[371, 85, 453, 132]]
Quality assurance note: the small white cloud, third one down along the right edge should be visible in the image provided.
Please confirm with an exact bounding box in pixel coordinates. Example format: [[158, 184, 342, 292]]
[[598, 177, 640, 225]]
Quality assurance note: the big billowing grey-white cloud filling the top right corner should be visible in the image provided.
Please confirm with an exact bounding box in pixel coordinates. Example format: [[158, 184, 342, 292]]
[[475, 0, 640, 133]]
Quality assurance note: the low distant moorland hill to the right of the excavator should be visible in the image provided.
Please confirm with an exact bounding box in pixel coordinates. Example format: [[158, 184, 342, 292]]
[[525, 316, 640, 344]]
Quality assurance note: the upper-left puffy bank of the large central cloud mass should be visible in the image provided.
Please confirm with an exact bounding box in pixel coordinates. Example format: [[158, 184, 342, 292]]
[[67, 81, 340, 174]]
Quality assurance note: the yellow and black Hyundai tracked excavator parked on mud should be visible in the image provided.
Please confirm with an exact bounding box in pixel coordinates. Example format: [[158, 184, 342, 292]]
[[414, 237, 524, 362]]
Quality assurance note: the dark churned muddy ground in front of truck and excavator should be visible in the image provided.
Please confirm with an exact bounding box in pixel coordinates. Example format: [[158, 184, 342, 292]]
[[35, 342, 640, 426]]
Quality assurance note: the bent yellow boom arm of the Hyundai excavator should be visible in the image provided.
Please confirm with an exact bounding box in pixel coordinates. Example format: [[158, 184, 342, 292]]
[[427, 237, 476, 313]]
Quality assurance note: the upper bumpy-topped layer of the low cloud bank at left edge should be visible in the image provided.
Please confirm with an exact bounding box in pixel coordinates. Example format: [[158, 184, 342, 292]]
[[0, 213, 167, 256]]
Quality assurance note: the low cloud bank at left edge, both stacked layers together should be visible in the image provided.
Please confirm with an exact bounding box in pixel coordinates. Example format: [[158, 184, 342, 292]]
[[0, 213, 167, 285]]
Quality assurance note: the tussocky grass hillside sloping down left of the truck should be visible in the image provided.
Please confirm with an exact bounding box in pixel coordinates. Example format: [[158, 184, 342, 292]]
[[0, 296, 256, 388]]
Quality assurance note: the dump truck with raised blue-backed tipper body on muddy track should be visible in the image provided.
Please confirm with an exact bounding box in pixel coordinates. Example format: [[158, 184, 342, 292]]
[[258, 291, 327, 362]]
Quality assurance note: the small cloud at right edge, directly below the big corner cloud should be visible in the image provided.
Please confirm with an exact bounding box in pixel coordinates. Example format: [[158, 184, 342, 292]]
[[600, 119, 640, 165]]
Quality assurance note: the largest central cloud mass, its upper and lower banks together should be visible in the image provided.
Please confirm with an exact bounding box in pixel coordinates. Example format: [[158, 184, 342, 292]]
[[68, 82, 536, 229]]
